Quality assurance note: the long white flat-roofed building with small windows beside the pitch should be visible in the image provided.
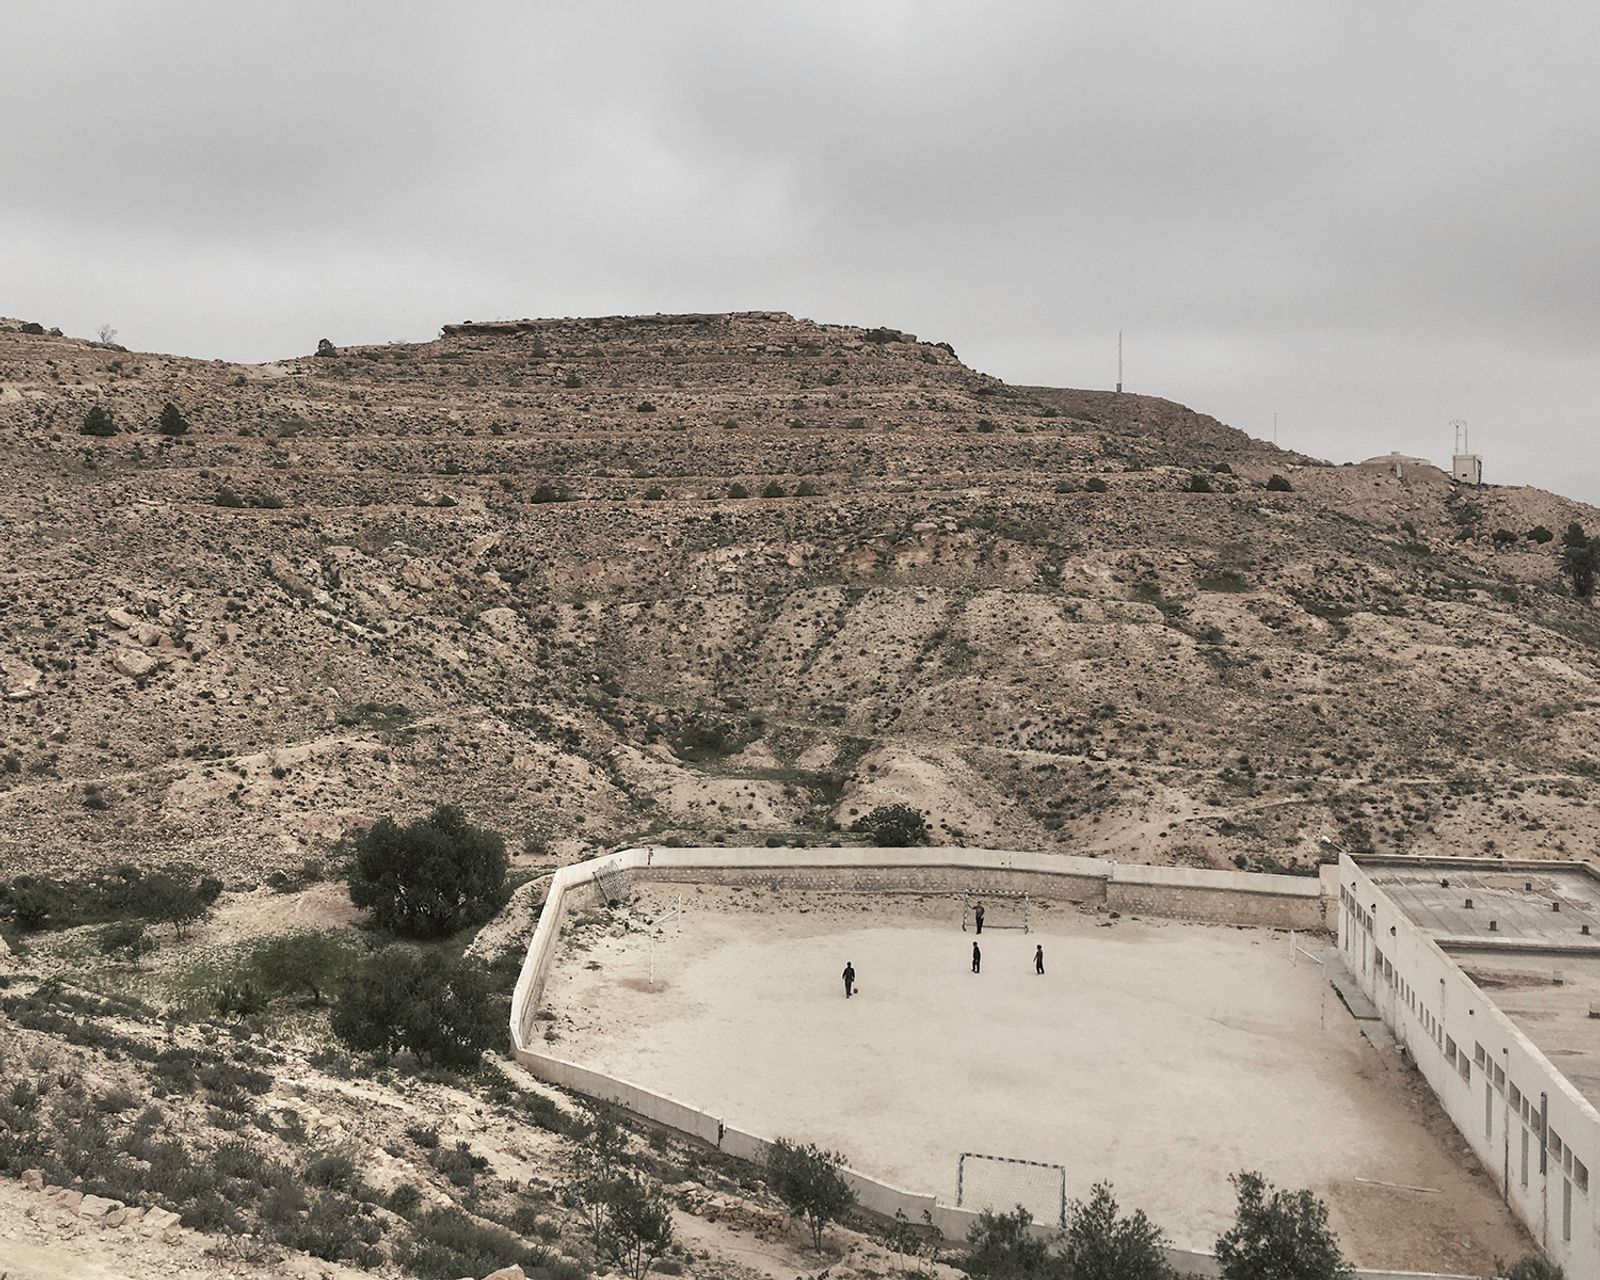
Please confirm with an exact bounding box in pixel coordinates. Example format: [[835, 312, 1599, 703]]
[[1339, 857, 1600, 1278]]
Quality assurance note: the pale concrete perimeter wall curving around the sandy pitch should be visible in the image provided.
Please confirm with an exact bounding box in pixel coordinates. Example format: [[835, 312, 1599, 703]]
[[510, 848, 1469, 1280]]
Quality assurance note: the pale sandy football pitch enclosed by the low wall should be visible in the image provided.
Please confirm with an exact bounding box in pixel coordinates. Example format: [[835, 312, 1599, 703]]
[[546, 886, 1523, 1269]]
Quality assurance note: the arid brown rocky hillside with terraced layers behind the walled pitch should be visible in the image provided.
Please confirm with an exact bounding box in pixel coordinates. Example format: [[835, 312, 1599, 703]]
[[0, 312, 1600, 888]]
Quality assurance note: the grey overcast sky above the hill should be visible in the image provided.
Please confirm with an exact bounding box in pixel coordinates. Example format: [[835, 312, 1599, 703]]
[[0, 0, 1600, 502]]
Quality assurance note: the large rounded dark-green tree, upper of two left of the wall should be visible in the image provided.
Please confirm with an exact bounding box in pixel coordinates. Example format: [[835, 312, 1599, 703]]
[[350, 805, 506, 938]]
